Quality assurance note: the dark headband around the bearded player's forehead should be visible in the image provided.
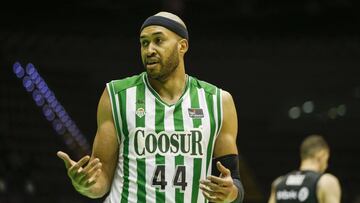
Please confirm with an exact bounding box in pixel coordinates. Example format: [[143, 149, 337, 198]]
[[140, 16, 189, 40]]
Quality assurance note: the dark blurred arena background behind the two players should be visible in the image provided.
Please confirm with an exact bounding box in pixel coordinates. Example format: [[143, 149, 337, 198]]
[[0, 0, 360, 203]]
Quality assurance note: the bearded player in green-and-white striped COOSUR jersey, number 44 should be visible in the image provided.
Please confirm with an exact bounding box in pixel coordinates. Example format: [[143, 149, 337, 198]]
[[58, 12, 244, 203]]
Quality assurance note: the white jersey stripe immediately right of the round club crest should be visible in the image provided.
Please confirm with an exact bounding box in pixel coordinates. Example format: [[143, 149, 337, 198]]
[[145, 86, 156, 202]]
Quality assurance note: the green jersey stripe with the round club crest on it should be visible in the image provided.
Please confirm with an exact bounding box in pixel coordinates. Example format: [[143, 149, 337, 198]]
[[135, 84, 146, 202]]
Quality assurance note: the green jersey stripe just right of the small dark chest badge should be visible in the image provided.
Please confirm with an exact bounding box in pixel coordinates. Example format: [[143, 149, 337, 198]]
[[206, 91, 215, 176]]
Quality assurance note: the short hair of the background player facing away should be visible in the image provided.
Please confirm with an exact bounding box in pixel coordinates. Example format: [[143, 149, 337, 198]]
[[300, 135, 329, 160]]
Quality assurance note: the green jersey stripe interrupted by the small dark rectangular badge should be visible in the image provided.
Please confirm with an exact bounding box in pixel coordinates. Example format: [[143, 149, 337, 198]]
[[190, 82, 202, 203]]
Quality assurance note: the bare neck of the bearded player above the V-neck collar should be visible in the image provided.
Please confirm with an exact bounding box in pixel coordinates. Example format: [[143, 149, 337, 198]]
[[149, 67, 188, 104]]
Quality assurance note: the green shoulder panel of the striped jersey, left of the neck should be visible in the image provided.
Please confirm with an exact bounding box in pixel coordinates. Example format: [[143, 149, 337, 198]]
[[107, 72, 145, 92]]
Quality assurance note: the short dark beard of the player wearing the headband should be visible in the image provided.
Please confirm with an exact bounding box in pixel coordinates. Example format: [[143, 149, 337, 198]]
[[146, 48, 179, 82]]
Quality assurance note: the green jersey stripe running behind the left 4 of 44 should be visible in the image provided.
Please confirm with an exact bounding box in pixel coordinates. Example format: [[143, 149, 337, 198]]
[[155, 100, 165, 203]]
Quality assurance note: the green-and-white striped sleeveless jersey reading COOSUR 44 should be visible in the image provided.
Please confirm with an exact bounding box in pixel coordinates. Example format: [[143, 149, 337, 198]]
[[105, 72, 222, 203]]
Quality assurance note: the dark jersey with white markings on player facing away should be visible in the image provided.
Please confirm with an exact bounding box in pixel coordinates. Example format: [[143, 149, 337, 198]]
[[275, 171, 321, 203]]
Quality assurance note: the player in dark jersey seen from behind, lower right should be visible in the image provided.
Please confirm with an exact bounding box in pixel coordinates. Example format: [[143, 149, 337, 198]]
[[269, 135, 341, 203]]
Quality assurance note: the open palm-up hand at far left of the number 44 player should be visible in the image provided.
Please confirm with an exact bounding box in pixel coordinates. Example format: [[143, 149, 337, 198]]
[[57, 151, 102, 194]]
